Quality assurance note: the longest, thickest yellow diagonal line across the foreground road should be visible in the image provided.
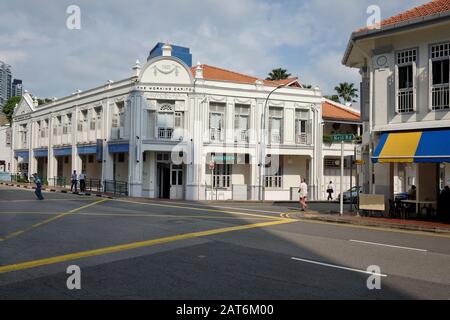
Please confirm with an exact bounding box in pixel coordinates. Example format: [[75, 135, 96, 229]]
[[0, 219, 297, 273]]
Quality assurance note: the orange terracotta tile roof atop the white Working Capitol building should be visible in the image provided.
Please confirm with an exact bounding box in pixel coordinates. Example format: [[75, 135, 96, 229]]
[[191, 64, 300, 87]]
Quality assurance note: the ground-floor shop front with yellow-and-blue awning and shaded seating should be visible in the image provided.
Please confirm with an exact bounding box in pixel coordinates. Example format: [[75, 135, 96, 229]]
[[372, 129, 450, 218]]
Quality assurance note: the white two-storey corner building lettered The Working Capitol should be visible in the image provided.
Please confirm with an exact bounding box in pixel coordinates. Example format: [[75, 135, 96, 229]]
[[12, 45, 323, 200]]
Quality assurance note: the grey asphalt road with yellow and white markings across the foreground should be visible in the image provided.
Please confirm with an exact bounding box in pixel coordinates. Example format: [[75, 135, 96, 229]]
[[0, 186, 450, 300]]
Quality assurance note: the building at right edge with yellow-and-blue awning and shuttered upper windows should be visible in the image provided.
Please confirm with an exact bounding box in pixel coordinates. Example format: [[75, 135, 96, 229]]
[[343, 0, 450, 209]]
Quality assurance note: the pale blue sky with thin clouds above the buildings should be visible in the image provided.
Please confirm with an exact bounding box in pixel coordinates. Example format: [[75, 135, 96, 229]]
[[0, 0, 426, 102]]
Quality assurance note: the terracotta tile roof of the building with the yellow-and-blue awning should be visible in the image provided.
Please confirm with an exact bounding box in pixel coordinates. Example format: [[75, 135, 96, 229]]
[[357, 0, 450, 32]]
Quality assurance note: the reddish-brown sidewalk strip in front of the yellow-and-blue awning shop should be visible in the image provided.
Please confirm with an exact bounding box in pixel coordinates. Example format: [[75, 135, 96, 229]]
[[288, 211, 450, 236]]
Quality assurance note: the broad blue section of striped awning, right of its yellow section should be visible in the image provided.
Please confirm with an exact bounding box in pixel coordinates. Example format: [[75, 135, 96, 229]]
[[414, 130, 450, 163]]
